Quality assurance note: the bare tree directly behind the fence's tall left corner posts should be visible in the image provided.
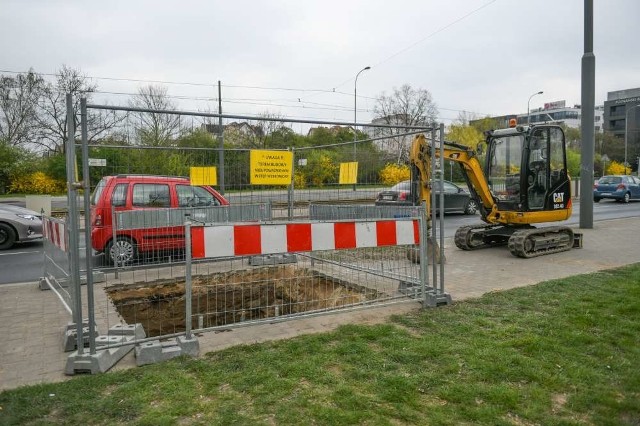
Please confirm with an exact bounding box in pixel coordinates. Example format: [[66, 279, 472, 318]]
[[33, 65, 125, 153]]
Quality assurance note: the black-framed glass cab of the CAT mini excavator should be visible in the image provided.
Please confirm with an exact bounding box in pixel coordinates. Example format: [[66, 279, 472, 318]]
[[484, 125, 571, 215]]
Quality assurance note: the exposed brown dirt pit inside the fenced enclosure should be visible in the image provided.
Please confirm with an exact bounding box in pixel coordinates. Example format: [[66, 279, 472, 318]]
[[107, 265, 377, 336]]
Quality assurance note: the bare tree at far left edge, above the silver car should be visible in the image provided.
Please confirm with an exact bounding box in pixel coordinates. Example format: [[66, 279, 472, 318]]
[[0, 70, 45, 147]]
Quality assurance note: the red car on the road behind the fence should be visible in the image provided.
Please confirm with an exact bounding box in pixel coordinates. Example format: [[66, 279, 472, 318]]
[[91, 175, 229, 265]]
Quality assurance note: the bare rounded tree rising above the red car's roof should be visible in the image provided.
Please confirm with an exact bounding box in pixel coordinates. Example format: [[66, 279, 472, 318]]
[[130, 84, 181, 146]]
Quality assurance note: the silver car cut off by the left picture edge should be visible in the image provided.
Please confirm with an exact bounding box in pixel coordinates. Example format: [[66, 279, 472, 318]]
[[0, 203, 42, 250]]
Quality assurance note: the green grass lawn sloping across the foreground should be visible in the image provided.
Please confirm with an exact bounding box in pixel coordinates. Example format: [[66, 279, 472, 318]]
[[0, 264, 640, 425]]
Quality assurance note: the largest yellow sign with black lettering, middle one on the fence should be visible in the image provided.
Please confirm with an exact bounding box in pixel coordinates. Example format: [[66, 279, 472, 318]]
[[249, 150, 293, 185]]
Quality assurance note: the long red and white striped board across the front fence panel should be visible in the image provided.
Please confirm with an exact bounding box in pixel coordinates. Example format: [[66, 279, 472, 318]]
[[191, 220, 420, 258]]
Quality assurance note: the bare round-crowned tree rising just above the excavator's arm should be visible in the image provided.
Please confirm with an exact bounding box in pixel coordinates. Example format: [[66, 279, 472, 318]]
[[374, 84, 438, 163]]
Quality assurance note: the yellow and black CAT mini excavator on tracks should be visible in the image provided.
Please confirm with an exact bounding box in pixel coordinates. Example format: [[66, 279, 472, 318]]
[[410, 120, 581, 258]]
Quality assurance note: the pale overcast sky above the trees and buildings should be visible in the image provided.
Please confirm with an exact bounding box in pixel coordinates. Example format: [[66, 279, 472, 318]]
[[0, 0, 640, 128]]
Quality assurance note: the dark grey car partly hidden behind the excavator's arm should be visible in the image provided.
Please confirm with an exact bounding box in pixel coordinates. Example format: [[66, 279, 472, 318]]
[[376, 180, 478, 214]]
